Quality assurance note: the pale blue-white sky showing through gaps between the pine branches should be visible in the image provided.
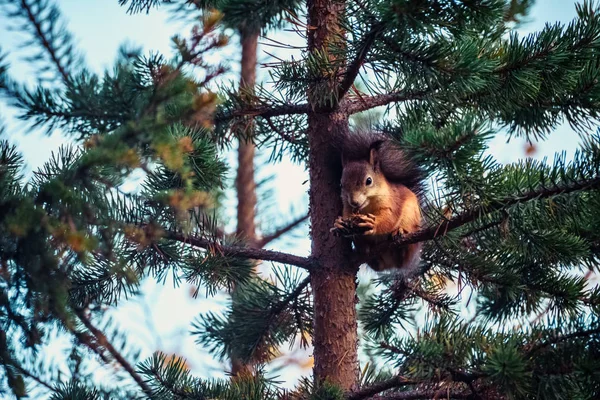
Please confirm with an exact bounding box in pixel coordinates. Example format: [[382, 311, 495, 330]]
[[0, 0, 592, 396]]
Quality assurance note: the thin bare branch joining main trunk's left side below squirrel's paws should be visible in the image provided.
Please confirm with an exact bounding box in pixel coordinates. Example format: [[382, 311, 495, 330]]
[[165, 231, 315, 270]]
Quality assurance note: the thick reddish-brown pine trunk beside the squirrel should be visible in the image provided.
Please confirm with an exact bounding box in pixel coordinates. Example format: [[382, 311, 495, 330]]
[[308, 0, 358, 390]]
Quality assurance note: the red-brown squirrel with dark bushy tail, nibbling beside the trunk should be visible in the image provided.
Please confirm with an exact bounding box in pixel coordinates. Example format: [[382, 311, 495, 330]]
[[331, 131, 423, 272]]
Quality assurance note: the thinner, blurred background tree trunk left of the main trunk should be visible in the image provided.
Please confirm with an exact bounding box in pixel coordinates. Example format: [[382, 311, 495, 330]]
[[231, 31, 258, 376]]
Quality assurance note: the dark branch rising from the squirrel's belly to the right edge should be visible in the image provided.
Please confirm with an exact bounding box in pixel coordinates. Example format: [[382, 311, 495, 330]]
[[393, 177, 600, 246]]
